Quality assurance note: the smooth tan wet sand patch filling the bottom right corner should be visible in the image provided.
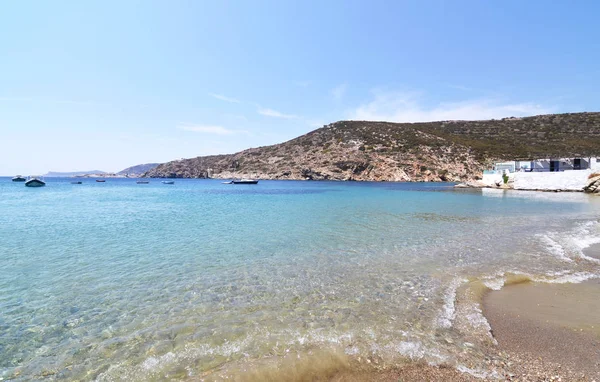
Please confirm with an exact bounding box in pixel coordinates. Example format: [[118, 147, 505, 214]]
[[483, 279, 600, 381]]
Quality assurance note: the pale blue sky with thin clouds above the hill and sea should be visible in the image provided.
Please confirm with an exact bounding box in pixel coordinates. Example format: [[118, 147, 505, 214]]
[[0, 0, 600, 175]]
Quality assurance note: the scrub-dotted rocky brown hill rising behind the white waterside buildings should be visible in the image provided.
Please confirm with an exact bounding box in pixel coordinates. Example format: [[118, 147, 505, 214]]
[[144, 113, 600, 181]]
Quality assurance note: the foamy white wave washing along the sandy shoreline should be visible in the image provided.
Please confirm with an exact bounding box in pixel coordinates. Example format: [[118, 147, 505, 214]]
[[72, 221, 600, 381]]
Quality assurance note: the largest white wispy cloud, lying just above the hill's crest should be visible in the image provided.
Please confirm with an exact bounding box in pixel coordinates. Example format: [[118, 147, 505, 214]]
[[347, 90, 556, 122]]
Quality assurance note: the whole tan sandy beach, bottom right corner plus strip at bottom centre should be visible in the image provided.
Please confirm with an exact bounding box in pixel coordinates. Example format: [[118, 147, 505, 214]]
[[220, 272, 600, 382]]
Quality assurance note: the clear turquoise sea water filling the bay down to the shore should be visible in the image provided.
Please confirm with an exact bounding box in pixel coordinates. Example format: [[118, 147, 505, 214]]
[[0, 178, 600, 380]]
